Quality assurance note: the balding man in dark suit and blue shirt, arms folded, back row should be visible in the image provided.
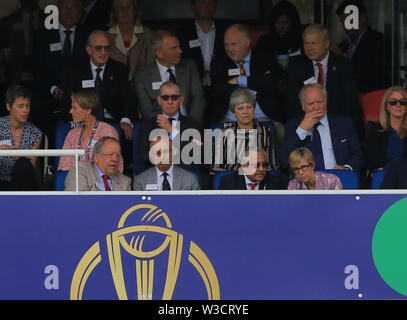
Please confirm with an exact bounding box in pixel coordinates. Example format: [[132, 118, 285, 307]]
[[210, 24, 283, 122]]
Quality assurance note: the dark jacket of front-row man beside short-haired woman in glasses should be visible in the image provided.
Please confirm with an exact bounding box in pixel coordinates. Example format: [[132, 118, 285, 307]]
[[218, 171, 281, 190]]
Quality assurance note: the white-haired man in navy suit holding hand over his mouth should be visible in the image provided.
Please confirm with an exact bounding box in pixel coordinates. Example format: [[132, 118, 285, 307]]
[[280, 83, 363, 170]]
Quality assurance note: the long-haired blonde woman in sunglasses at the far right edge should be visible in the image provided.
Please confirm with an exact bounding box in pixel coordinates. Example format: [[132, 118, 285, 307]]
[[366, 86, 407, 169]]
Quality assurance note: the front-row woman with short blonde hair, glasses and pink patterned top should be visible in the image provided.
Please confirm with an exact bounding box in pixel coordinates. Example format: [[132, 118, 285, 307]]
[[288, 148, 342, 190]]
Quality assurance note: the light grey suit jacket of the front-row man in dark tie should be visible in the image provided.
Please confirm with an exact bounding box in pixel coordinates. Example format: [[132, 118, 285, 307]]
[[133, 165, 200, 191]]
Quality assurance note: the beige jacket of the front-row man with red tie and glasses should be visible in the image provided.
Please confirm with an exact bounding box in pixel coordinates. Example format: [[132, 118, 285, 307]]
[[65, 161, 131, 191]]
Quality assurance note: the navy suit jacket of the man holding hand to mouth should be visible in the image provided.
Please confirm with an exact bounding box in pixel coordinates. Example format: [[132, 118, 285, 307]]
[[280, 114, 363, 170]]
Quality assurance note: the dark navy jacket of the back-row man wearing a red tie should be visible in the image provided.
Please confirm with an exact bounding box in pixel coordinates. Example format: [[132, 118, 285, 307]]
[[286, 52, 359, 118]]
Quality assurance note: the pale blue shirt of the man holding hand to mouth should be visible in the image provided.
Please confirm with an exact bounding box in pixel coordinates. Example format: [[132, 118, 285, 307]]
[[296, 114, 336, 169]]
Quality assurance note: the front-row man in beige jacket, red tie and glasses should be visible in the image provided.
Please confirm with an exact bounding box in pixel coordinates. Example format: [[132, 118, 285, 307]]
[[65, 137, 131, 191]]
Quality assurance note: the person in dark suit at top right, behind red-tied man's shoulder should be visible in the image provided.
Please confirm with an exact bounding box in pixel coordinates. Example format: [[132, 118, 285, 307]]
[[336, 0, 391, 93]]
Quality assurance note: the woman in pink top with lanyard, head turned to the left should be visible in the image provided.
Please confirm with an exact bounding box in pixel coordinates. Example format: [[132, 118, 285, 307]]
[[58, 89, 123, 172]]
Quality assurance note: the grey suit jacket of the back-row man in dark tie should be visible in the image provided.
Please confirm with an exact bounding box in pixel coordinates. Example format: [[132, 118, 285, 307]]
[[132, 59, 206, 123]]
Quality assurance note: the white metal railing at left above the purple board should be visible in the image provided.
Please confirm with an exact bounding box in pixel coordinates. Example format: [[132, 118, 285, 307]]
[[0, 149, 85, 192]]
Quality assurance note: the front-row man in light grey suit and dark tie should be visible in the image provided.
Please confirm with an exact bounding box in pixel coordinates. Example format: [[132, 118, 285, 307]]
[[133, 135, 200, 191]]
